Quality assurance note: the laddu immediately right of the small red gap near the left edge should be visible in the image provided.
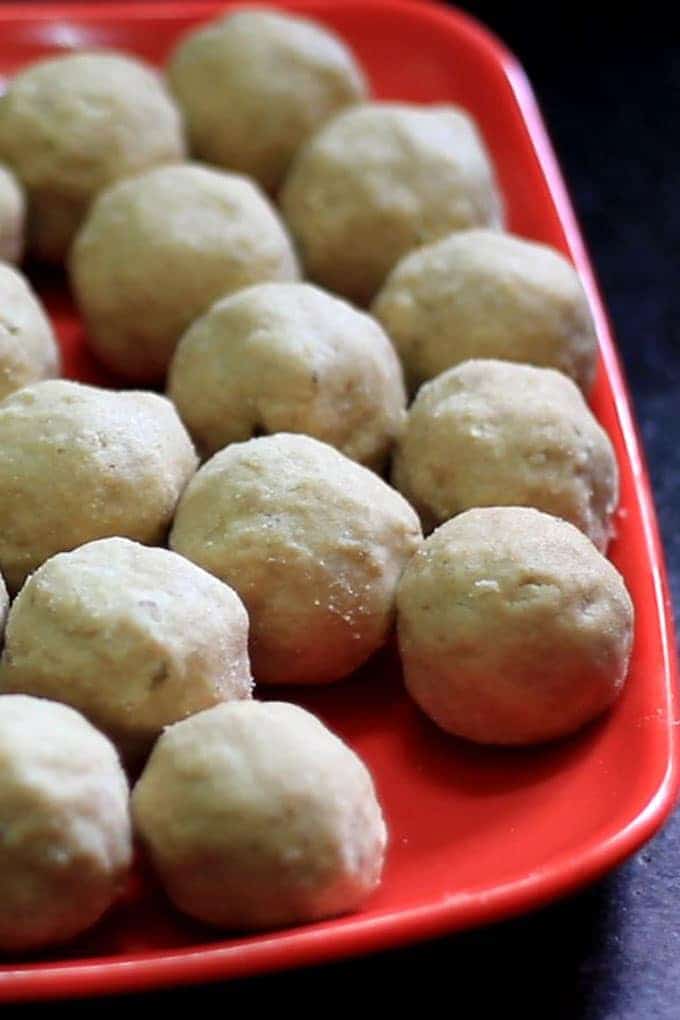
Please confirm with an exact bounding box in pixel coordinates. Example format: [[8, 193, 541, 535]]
[[70, 164, 299, 380]]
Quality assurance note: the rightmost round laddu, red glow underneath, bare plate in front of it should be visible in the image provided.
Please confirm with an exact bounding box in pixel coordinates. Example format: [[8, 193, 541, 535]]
[[397, 507, 633, 745]]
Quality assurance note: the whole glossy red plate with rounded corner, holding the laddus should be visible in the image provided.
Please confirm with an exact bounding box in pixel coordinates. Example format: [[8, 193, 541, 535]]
[[0, 0, 678, 999]]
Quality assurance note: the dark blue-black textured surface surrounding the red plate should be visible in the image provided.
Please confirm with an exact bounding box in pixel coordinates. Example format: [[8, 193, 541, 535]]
[[9, 2, 680, 1020]]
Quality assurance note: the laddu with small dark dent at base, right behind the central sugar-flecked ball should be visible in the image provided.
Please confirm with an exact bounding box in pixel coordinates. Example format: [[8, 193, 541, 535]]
[[168, 284, 406, 469]]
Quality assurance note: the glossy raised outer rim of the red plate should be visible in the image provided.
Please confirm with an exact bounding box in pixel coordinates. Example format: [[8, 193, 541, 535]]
[[0, 0, 680, 1002]]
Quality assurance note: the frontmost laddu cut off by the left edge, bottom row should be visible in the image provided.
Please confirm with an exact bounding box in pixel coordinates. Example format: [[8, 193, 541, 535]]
[[0, 695, 133, 953]]
